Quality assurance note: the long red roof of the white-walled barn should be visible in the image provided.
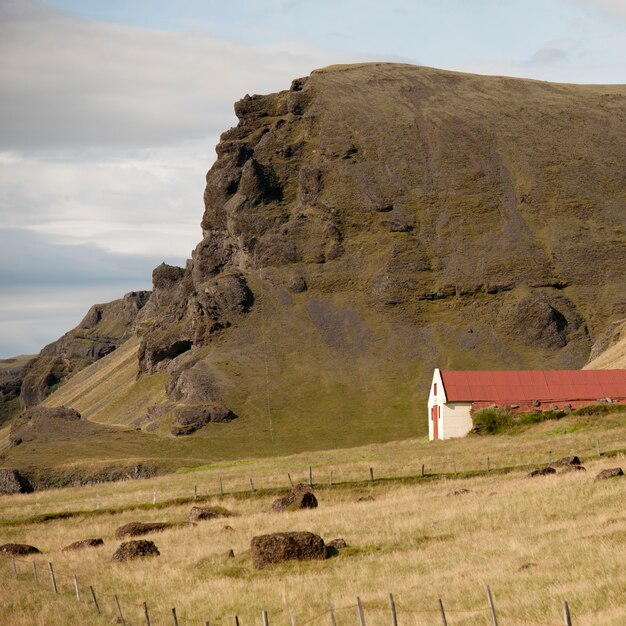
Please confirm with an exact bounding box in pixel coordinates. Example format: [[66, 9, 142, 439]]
[[441, 370, 626, 403]]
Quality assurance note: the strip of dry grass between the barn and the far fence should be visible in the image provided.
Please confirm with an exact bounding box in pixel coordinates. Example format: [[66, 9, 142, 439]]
[[0, 414, 626, 522]]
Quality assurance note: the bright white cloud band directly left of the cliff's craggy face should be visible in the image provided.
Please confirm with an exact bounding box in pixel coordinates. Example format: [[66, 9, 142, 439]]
[[0, 138, 210, 258]]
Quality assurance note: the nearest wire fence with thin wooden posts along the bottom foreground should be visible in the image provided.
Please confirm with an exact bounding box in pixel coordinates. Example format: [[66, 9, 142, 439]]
[[1, 554, 572, 626]]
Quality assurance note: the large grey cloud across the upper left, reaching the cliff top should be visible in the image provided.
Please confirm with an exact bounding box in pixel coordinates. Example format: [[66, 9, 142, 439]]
[[0, 0, 346, 150]]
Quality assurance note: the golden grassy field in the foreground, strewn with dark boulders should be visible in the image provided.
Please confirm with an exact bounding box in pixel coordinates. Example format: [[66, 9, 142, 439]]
[[0, 415, 626, 626]]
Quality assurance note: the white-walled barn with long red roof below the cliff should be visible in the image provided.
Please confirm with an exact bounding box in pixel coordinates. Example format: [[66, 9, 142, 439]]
[[428, 369, 626, 441]]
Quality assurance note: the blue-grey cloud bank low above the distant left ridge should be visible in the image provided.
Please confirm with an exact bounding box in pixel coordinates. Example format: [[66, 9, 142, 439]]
[[0, 229, 180, 358]]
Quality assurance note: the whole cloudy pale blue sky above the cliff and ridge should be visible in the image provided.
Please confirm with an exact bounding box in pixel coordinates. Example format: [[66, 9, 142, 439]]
[[0, 0, 626, 358]]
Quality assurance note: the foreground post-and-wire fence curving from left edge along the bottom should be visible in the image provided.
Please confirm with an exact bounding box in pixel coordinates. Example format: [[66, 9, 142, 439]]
[[0, 553, 573, 626]]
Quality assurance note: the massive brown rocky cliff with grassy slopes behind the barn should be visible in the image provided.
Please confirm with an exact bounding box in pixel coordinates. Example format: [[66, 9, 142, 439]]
[[6, 64, 626, 445]]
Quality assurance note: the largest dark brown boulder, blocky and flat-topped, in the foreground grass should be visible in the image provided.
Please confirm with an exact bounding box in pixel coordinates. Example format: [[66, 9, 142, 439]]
[[250, 531, 326, 569]]
